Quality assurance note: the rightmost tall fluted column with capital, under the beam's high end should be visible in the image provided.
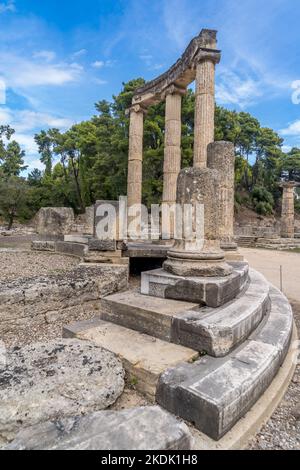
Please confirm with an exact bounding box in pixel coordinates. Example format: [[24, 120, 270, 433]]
[[194, 53, 220, 168]]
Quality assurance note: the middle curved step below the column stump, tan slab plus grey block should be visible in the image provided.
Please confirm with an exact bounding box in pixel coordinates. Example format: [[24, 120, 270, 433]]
[[101, 271, 269, 357]]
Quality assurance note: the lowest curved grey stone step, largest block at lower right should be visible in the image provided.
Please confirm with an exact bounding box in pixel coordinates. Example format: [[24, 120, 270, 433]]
[[156, 287, 293, 440]]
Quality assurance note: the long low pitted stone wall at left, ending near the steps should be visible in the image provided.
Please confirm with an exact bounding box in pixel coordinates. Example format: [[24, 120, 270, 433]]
[[0, 264, 128, 343]]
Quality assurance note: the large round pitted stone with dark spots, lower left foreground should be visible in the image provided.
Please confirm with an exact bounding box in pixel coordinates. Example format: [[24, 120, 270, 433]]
[[0, 340, 124, 445]]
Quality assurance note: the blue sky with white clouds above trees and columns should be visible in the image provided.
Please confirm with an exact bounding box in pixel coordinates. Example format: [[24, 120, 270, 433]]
[[0, 0, 300, 173]]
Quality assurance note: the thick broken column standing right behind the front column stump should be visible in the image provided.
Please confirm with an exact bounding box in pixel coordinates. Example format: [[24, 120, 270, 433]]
[[207, 142, 237, 250]]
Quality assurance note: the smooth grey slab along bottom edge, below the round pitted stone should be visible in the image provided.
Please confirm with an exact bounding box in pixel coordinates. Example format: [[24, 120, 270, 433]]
[[7, 406, 193, 451]]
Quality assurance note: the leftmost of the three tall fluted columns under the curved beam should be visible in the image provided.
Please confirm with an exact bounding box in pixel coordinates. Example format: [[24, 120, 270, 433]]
[[127, 105, 145, 207]]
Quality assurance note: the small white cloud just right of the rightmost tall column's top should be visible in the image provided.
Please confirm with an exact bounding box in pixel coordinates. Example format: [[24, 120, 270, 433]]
[[216, 69, 263, 108]]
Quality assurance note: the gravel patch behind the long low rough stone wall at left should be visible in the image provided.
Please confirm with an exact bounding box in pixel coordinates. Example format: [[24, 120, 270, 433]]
[[0, 249, 78, 282]]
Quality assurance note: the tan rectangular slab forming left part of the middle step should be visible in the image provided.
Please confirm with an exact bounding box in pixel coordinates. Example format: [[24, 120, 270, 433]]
[[101, 291, 198, 341]]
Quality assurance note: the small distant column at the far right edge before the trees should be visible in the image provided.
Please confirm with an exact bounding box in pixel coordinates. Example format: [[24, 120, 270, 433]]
[[281, 181, 298, 238]]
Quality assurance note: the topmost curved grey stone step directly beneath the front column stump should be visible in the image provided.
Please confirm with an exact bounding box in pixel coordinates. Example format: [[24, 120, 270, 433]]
[[141, 263, 249, 307]]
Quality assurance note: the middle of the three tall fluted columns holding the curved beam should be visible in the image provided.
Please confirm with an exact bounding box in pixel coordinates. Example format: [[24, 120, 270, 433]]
[[163, 86, 185, 204]]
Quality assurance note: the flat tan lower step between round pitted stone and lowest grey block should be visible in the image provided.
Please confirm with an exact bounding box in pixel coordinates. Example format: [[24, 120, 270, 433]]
[[63, 319, 199, 400]]
